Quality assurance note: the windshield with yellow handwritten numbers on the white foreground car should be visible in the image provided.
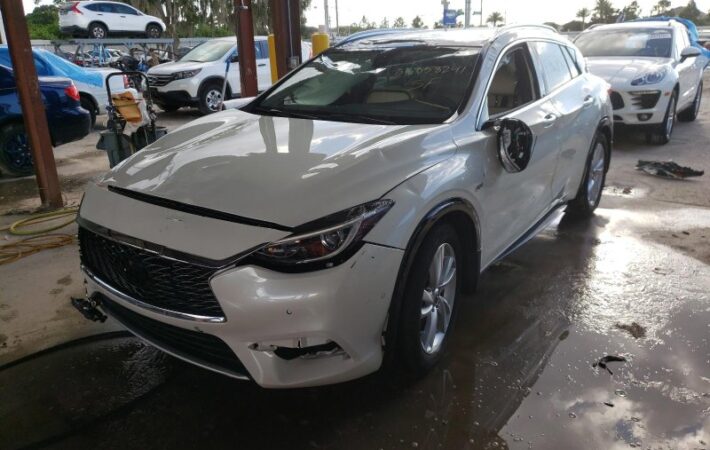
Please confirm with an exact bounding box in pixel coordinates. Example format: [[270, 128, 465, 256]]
[[249, 45, 480, 125]]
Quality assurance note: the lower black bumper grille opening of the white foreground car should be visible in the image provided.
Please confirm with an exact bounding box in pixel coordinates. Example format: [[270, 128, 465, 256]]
[[100, 296, 248, 377]]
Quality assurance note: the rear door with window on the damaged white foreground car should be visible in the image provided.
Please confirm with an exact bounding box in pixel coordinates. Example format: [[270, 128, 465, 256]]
[[531, 41, 600, 202]]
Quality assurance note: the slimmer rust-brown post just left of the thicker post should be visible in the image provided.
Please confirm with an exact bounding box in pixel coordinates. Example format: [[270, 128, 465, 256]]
[[234, 0, 259, 97]]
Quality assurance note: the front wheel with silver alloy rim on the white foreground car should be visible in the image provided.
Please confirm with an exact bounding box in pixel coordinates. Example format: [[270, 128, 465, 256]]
[[396, 224, 464, 377]]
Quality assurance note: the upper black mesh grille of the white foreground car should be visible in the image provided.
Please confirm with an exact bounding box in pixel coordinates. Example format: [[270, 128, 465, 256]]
[[79, 227, 224, 317]]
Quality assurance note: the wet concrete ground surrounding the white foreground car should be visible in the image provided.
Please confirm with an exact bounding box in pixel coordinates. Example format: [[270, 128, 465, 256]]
[[0, 89, 710, 449]]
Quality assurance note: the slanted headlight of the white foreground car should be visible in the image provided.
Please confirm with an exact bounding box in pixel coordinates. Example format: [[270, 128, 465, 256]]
[[252, 200, 394, 270]]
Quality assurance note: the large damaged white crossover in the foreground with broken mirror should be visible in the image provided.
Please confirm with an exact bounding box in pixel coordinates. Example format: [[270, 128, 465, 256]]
[[75, 26, 613, 387]]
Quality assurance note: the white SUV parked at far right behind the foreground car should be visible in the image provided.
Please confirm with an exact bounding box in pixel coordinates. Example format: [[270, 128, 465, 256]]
[[575, 20, 708, 144]]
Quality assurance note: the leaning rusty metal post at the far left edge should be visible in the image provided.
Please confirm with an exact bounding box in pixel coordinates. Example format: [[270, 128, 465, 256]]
[[0, 0, 64, 208]]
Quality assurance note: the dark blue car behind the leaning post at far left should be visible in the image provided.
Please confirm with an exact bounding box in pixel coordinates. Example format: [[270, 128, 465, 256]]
[[0, 65, 91, 176]]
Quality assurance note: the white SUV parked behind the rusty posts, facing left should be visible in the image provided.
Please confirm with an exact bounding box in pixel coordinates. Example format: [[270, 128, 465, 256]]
[[148, 36, 311, 114]]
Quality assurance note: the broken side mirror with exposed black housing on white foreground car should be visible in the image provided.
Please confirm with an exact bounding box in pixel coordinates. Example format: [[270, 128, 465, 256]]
[[493, 119, 534, 173]]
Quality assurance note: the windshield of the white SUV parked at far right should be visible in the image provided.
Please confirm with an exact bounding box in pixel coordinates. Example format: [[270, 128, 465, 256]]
[[574, 28, 673, 58]]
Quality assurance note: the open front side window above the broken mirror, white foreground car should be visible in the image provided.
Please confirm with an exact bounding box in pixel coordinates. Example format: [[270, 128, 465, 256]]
[[486, 46, 539, 117]]
